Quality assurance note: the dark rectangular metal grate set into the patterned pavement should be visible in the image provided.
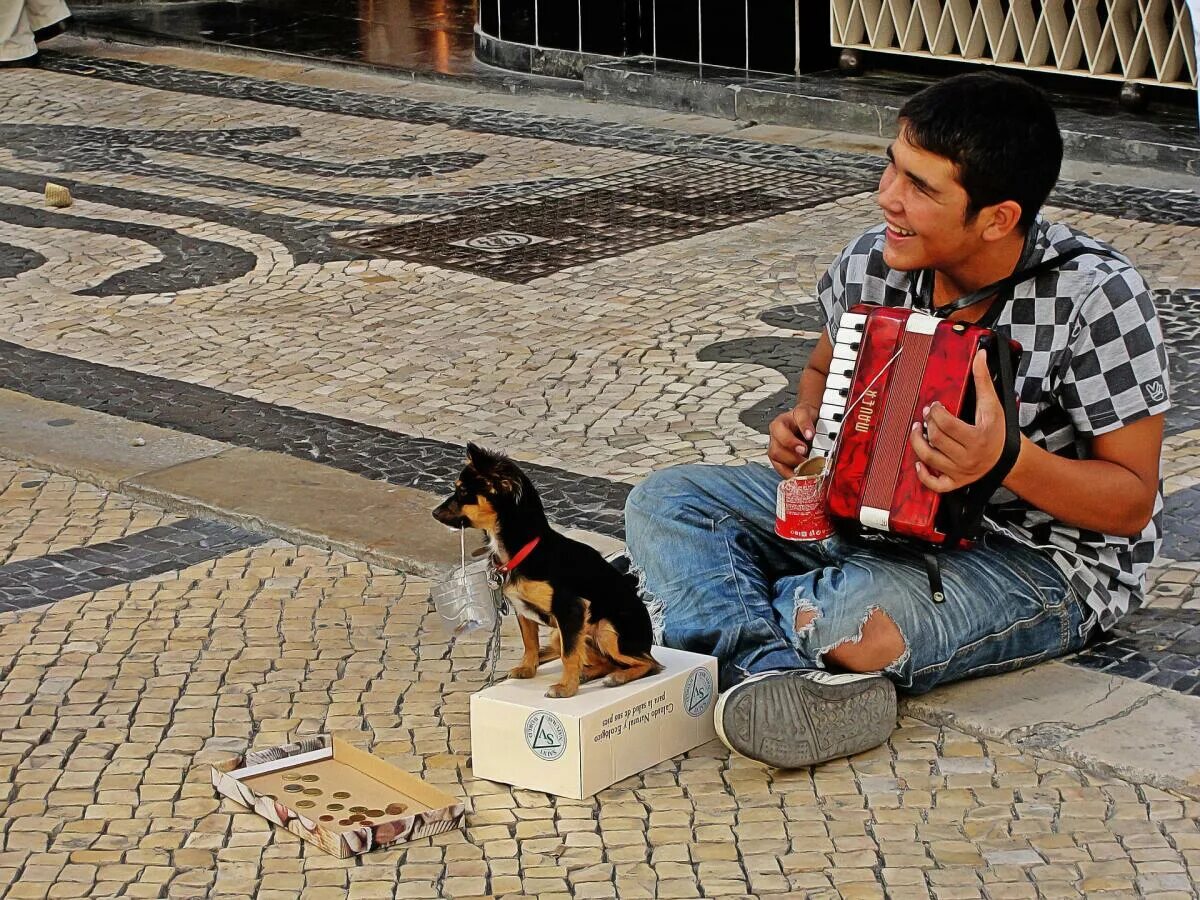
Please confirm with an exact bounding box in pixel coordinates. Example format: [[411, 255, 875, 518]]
[[340, 160, 863, 283]]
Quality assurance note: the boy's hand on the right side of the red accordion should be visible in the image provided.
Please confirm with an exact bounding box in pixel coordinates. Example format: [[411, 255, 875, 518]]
[[910, 350, 1004, 493]]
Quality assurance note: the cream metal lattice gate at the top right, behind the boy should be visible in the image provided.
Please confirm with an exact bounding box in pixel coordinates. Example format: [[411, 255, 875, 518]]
[[830, 0, 1196, 88]]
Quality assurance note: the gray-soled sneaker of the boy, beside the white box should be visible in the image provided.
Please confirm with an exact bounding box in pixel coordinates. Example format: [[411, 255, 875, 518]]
[[715, 668, 896, 769]]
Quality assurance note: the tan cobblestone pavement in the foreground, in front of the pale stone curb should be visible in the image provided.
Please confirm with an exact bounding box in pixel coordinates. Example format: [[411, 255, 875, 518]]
[[0, 463, 1200, 900]]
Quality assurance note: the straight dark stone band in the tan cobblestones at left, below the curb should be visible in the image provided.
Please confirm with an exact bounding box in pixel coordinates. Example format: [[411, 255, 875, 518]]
[[0, 518, 268, 612]]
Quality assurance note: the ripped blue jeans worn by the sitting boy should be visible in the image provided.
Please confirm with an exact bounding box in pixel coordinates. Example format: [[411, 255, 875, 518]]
[[625, 464, 1092, 694]]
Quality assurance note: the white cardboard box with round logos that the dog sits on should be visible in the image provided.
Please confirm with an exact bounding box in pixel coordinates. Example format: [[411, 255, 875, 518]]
[[470, 647, 716, 799]]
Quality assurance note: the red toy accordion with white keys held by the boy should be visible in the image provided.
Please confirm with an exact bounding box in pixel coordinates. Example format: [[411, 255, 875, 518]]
[[812, 305, 1021, 547]]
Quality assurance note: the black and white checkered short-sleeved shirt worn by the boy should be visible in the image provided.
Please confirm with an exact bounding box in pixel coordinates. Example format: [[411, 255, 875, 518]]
[[817, 216, 1170, 628]]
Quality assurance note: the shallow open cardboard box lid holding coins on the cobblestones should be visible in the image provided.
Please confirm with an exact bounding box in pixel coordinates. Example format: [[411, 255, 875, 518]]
[[212, 734, 464, 859]]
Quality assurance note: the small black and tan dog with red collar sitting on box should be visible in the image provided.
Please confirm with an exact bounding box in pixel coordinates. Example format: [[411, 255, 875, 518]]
[[433, 444, 662, 697]]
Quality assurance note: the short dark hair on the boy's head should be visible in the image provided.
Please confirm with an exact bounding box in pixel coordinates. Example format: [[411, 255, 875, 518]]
[[900, 71, 1062, 232]]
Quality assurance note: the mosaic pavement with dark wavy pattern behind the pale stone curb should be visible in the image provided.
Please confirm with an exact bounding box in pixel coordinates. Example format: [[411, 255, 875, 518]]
[[0, 54, 1200, 705]]
